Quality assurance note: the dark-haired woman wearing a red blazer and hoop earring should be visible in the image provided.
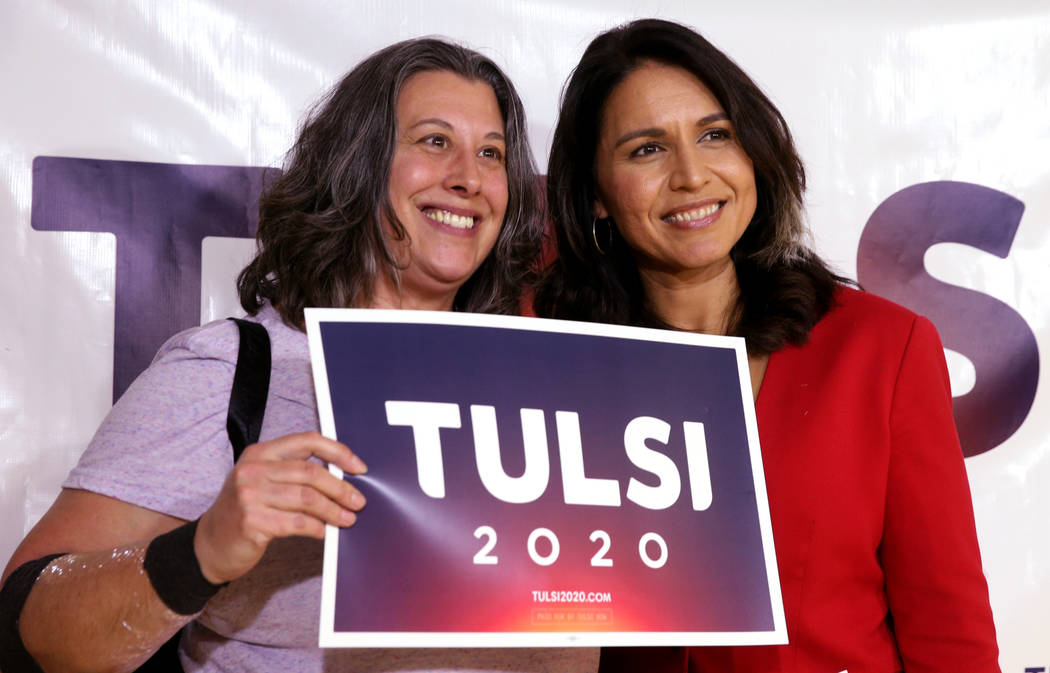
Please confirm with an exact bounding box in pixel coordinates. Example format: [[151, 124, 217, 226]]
[[534, 20, 999, 673]]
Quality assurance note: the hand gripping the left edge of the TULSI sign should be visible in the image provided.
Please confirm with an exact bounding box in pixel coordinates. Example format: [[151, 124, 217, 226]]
[[193, 432, 366, 584]]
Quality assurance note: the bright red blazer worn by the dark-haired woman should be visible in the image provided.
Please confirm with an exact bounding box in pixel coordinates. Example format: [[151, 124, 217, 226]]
[[602, 288, 1000, 673]]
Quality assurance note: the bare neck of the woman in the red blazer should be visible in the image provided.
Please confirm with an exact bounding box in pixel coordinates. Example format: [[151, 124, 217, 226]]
[[639, 259, 740, 335]]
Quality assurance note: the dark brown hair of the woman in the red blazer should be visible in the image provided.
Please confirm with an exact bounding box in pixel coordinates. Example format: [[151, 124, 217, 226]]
[[533, 19, 848, 355]]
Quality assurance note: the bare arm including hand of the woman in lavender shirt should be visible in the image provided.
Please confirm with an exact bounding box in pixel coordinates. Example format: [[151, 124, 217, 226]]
[[4, 433, 364, 673]]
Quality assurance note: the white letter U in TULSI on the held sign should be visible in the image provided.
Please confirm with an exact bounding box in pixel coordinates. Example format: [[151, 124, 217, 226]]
[[470, 404, 550, 503]]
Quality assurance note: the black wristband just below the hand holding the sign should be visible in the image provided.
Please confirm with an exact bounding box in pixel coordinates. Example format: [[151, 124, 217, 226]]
[[142, 521, 229, 614]]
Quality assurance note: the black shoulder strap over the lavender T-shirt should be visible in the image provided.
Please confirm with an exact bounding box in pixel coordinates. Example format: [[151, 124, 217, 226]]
[[226, 318, 271, 462]]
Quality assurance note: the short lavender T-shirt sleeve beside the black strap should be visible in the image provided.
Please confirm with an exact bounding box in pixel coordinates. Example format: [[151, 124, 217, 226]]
[[63, 321, 237, 520]]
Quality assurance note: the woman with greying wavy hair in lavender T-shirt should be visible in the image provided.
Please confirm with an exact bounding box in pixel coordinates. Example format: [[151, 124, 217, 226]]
[[0, 39, 597, 673]]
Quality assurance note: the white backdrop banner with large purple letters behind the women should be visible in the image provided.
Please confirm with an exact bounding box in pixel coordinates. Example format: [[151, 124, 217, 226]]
[[0, 0, 1050, 673]]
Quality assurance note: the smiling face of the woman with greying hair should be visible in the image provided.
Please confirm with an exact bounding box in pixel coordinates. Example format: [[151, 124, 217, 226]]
[[373, 70, 507, 310]]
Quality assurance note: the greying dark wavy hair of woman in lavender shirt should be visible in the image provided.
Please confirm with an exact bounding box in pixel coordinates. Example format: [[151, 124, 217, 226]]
[[237, 38, 543, 329]]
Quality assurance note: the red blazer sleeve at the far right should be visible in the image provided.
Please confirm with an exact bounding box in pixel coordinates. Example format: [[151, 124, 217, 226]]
[[880, 317, 1000, 673]]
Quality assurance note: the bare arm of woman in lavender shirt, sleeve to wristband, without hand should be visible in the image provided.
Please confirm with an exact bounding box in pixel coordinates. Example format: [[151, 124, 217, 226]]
[[4, 490, 191, 671]]
